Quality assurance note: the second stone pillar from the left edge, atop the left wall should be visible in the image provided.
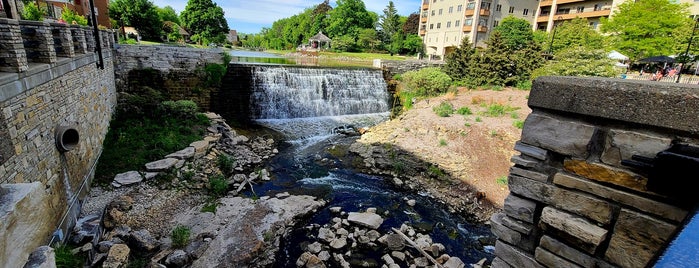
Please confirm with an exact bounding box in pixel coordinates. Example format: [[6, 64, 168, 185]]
[[19, 20, 57, 64]]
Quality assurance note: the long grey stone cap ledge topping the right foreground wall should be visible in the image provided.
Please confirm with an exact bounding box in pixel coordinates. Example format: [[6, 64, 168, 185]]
[[529, 76, 699, 135]]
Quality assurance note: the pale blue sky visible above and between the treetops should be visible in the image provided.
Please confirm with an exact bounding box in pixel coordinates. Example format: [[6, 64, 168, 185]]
[[153, 0, 422, 33]]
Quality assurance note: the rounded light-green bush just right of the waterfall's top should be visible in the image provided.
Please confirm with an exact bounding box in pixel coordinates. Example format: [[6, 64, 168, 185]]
[[403, 67, 452, 96]]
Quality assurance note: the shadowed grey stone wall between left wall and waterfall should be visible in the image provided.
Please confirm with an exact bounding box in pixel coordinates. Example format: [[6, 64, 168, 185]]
[[114, 45, 224, 110]]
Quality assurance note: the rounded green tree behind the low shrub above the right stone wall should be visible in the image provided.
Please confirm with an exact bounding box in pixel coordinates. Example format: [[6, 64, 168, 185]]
[[546, 17, 605, 54]]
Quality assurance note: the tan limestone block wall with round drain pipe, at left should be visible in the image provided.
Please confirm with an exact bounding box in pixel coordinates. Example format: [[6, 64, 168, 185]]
[[0, 19, 116, 267]]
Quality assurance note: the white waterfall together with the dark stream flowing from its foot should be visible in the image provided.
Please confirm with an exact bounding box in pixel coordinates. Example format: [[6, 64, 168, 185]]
[[232, 63, 493, 267]]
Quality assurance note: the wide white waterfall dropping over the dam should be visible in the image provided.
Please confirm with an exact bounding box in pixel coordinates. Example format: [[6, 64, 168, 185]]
[[250, 66, 389, 119]]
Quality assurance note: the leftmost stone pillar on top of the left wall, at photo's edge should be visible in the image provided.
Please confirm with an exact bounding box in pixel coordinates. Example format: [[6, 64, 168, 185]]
[[0, 18, 29, 73]]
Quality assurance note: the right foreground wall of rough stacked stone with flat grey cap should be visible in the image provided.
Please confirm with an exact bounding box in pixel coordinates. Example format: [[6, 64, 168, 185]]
[[491, 77, 699, 267]]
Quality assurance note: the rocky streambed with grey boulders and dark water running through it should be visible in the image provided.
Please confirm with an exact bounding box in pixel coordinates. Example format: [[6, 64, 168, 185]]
[[69, 114, 494, 267]]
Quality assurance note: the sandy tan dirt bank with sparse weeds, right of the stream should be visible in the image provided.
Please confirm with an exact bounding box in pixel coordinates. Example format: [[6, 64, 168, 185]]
[[355, 88, 531, 216]]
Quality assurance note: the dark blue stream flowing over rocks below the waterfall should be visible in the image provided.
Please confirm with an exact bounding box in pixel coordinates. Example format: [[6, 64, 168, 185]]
[[243, 113, 494, 267]]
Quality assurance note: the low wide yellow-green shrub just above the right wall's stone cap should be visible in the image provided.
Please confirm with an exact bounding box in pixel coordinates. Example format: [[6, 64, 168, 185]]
[[532, 46, 620, 79]]
